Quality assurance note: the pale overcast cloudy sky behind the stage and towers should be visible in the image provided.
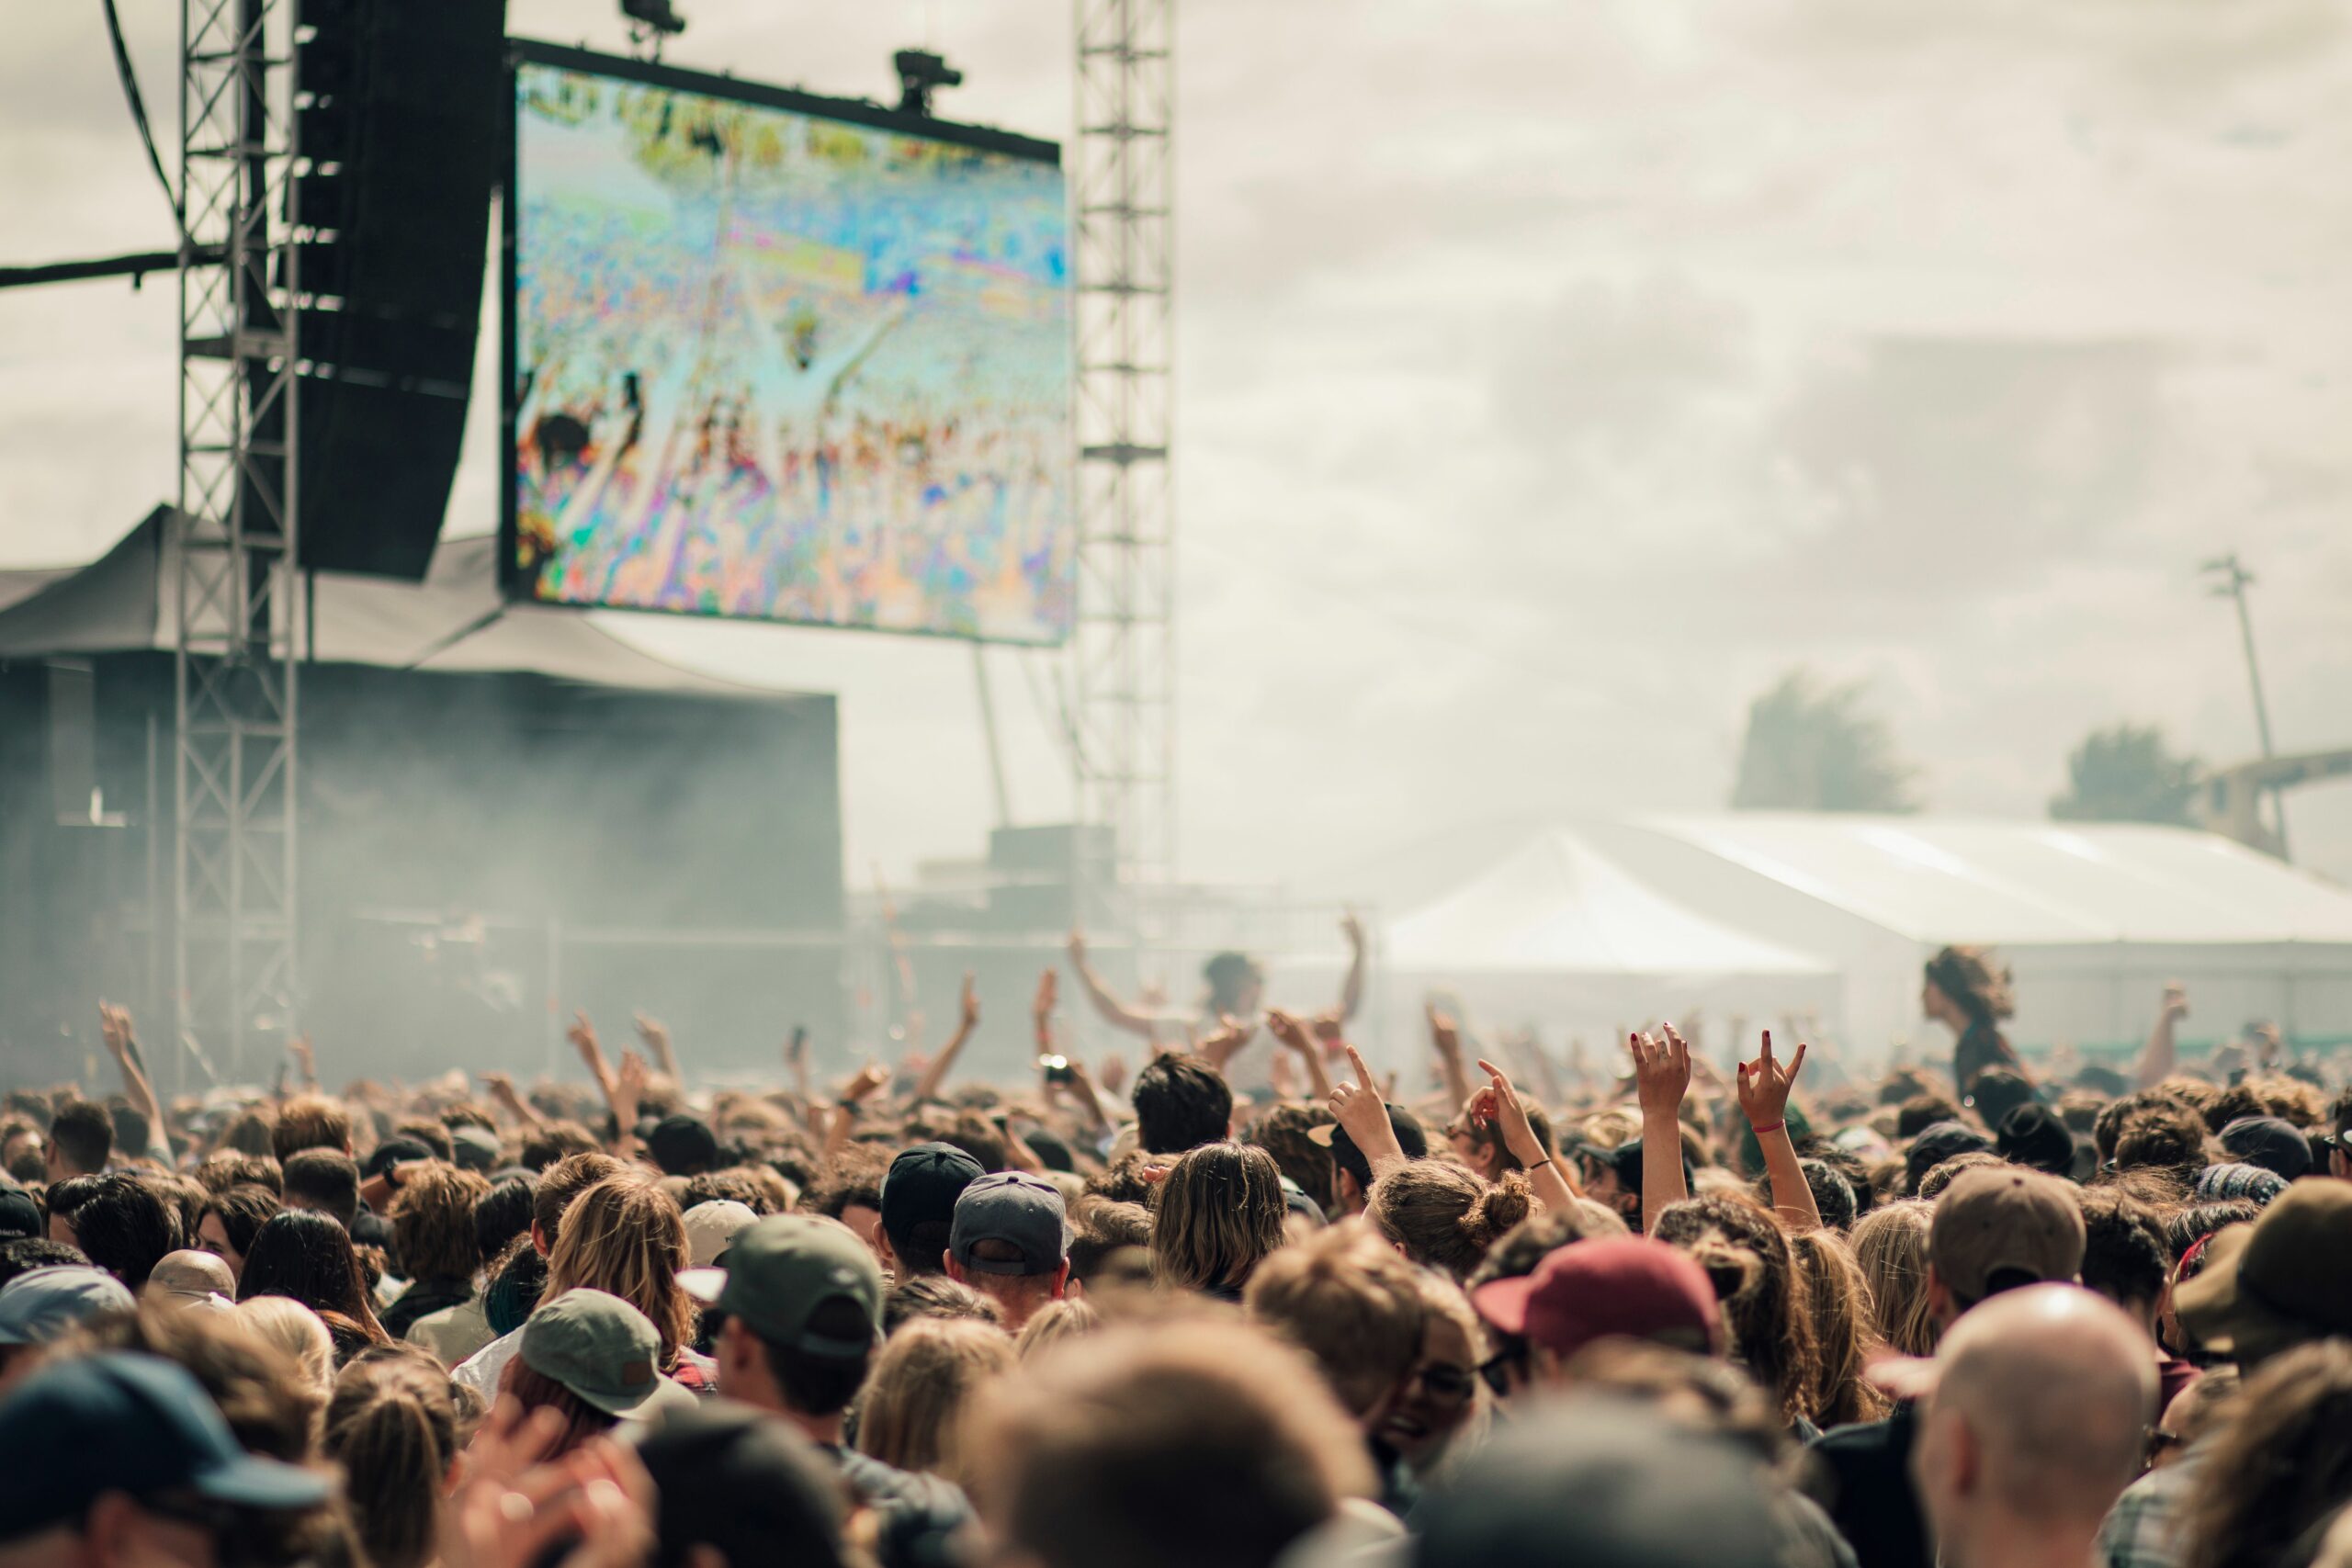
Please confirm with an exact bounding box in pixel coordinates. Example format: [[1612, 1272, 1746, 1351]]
[[0, 0, 2352, 903]]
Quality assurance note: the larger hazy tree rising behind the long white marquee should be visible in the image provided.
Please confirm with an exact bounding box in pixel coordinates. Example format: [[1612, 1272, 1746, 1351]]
[[1731, 670, 1919, 811]]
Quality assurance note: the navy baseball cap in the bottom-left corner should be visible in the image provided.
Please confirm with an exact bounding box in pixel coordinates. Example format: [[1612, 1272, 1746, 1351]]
[[0, 1352, 329, 1542]]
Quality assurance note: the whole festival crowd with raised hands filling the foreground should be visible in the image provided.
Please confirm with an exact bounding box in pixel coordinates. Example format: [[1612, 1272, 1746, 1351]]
[[0, 942, 2352, 1568]]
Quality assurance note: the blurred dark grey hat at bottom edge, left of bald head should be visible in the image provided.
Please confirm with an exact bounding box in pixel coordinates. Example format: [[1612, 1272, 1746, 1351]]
[[1407, 1401, 1782, 1568]]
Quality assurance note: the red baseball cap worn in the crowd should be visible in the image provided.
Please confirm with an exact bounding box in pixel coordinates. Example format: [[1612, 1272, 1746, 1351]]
[[1470, 1236, 1724, 1357]]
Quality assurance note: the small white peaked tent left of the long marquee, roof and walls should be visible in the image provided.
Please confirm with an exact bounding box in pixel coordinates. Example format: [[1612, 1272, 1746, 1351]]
[[1387, 829, 1839, 1046]]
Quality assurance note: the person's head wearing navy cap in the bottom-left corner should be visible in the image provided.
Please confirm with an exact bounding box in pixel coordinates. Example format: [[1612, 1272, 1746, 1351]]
[[0, 1352, 329, 1568]]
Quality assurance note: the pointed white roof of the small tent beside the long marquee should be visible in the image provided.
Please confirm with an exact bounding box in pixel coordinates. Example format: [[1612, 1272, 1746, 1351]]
[[1387, 829, 1830, 976]]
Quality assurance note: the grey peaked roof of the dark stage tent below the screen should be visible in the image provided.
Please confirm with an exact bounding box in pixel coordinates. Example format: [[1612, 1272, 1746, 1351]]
[[0, 505, 818, 698]]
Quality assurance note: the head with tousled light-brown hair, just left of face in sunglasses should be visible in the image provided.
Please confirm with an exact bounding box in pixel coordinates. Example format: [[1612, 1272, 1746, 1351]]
[[1242, 1223, 1430, 1432]]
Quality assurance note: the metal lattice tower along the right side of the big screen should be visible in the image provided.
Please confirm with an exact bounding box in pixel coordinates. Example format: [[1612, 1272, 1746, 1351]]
[[1072, 0, 1176, 942]]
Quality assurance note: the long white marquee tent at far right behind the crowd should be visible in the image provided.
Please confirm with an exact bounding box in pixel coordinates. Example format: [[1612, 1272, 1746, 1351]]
[[1590, 813, 2352, 1055]]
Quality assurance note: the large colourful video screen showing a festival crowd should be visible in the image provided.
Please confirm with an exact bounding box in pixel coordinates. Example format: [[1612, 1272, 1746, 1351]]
[[505, 50, 1077, 642]]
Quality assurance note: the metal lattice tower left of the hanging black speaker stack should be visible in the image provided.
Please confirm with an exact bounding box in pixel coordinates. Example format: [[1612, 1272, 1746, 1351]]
[[172, 0, 306, 1072]]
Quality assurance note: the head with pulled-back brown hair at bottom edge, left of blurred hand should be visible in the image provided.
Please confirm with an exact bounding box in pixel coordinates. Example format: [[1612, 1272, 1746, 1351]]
[[320, 1333, 458, 1568]]
